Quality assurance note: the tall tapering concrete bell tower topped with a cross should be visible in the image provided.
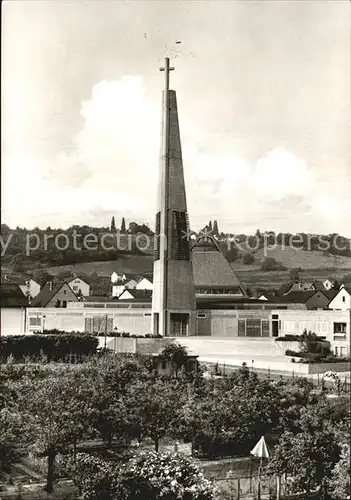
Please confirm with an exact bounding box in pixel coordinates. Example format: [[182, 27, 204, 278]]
[[152, 58, 196, 336]]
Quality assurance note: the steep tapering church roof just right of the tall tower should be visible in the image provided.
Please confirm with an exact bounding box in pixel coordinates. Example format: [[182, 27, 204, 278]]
[[191, 234, 245, 295]]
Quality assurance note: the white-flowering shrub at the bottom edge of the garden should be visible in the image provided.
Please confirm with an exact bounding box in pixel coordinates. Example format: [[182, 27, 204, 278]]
[[73, 452, 215, 500]]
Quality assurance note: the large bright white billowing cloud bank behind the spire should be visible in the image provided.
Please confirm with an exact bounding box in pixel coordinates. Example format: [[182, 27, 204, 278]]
[[3, 76, 350, 236]]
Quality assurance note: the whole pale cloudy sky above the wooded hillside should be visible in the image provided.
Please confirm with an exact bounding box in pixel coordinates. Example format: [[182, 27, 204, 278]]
[[1, 0, 351, 237]]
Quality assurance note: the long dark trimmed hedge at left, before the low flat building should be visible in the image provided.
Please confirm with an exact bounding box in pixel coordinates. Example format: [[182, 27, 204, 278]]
[[0, 334, 99, 362]]
